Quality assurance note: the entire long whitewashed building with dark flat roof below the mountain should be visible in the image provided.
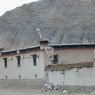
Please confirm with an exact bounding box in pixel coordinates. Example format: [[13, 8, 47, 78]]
[[0, 40, 95, 86]]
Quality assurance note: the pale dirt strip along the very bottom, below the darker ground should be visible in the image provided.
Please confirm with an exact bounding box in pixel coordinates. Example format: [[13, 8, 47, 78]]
[[0, 88, 89, 95]]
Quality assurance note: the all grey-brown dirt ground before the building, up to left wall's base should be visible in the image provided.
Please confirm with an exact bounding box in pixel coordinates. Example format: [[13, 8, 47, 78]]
[[0, 80, 95, 95]]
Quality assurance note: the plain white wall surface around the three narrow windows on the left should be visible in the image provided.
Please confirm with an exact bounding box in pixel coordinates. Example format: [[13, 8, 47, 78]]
[[0, 52, 44, 79]]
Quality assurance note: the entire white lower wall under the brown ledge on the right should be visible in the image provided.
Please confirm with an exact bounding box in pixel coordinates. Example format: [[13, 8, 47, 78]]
[[49, 67, 95, 86]]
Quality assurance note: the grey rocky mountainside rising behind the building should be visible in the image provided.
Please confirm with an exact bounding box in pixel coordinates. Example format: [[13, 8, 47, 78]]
[[0, 0, 95, 50]]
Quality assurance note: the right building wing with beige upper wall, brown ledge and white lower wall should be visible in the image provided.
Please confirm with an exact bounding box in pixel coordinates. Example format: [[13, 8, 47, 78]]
[[46, 44, 95, 86]]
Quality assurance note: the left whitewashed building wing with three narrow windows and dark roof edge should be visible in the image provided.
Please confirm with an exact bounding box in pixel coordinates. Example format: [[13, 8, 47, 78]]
[[0, 40, 48, 79]]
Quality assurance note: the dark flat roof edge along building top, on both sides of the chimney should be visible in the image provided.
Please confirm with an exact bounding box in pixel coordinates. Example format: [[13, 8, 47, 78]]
[[1, 43, 95, 56]]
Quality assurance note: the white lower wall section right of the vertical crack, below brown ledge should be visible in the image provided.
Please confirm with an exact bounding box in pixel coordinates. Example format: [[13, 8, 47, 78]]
[[64, 67, 95, 86]]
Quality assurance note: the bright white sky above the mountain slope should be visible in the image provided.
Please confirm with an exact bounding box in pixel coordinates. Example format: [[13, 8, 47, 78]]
[[0, 0, 37, 16]]
